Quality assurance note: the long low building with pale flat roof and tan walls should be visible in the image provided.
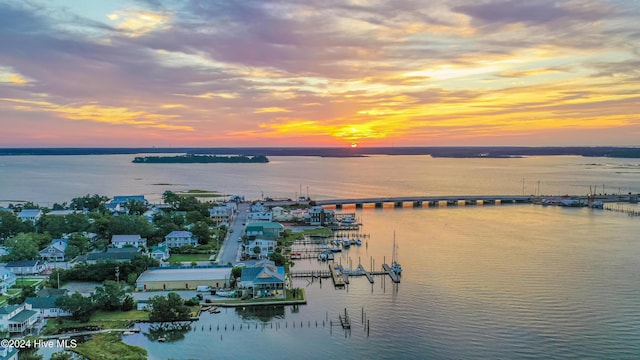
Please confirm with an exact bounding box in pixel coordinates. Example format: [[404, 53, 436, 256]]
[[136, 267, 231, 291]]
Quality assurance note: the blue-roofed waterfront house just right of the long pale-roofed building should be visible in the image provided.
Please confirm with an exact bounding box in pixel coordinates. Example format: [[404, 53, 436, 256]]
[[238, 265, 285, 298]]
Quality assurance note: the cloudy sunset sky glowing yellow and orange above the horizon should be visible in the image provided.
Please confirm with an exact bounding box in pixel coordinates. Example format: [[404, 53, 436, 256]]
[[0, 0, 640, 147]]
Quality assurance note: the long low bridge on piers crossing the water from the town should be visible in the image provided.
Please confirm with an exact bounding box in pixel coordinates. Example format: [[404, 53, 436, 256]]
[[315, 195, 533, 209]]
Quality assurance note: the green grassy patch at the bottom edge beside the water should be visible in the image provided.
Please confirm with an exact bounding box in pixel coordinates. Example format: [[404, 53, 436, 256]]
[[74, 334, 147, 360]]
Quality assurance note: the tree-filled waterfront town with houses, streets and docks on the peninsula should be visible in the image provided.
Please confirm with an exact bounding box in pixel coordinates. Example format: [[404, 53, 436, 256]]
[[0, 190, 360, 359]]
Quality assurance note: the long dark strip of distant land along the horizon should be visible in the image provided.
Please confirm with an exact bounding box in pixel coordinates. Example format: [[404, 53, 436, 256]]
[[0, 146, 640, 158]]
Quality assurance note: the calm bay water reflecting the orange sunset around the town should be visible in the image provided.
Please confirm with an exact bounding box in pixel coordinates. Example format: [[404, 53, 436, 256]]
[[0, 155, 640, 359]]
